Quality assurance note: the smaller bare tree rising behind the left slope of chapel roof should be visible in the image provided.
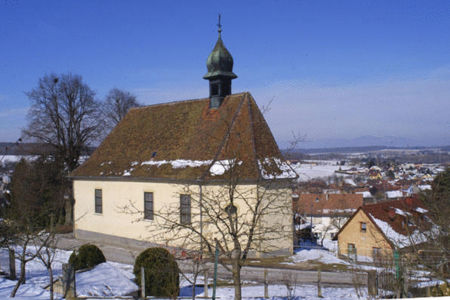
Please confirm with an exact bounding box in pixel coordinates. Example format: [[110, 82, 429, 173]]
[[103, 88, 141, 131]]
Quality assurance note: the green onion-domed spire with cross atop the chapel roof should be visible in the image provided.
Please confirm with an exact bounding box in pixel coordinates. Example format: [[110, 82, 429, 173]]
[[203, 14, 237, 108]]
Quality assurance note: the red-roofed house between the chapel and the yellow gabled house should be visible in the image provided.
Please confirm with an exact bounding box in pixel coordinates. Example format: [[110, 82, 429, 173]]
[[294, 193, 363, 239]]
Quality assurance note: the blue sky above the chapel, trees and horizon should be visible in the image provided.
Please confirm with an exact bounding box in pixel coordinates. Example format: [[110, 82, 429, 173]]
[[0, 0, 450, 145]]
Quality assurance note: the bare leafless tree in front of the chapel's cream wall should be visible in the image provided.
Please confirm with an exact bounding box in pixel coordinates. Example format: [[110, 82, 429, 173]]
[[122, 159, 293, 299]]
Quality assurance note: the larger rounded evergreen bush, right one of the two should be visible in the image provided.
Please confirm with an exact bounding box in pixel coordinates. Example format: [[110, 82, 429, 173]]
[[133, 248, 180, 298]]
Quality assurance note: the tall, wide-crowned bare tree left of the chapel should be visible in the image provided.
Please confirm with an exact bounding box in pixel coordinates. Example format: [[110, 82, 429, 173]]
[[23, 74, 103, 224]]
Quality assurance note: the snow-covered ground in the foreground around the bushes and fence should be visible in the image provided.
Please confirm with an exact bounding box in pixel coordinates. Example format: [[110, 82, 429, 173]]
[[0, 249, 370, 300]]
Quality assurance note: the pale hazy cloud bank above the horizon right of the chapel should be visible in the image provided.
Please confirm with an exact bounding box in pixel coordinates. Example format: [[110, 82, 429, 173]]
[[252, 68, 450, 143]]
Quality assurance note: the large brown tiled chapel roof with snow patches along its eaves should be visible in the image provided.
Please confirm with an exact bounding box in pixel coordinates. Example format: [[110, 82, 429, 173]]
[[72, 93, 296, 180]]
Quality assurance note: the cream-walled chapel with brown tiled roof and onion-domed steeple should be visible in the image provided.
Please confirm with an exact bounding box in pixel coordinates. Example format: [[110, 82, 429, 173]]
[[71, 25, 298, 256]]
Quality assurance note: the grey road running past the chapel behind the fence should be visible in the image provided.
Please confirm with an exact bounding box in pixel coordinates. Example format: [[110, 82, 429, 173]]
[[57, 234, 367, 286]]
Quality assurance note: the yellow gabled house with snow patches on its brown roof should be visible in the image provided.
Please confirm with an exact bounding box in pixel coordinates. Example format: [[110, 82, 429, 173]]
[[334, 198, 427, 261]]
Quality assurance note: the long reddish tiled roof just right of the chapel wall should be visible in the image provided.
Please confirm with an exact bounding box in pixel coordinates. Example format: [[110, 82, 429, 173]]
[[297, 194, 363, 215]]
